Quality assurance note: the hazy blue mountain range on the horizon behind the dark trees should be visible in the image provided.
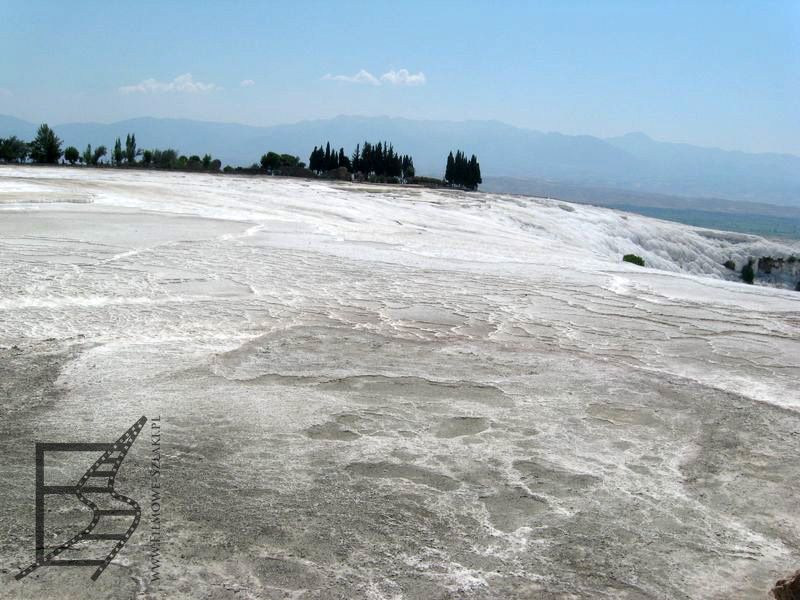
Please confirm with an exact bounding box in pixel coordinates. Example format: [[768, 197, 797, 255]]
[[0, 115, 800, 208]]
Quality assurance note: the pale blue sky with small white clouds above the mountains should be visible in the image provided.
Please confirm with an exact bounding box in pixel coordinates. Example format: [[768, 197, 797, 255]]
[[0, 0, 800, 154]]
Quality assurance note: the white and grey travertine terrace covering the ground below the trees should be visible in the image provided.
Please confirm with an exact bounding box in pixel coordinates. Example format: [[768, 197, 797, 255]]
[[0, 167, 800, 599]]
